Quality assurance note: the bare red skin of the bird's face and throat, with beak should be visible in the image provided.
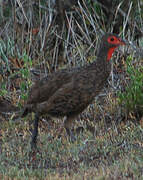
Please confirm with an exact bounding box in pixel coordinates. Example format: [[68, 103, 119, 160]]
[[107, 35, 126, 61]]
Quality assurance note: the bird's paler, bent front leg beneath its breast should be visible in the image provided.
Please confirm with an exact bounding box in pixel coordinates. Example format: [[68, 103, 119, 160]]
[[64, 117, 76, 142]]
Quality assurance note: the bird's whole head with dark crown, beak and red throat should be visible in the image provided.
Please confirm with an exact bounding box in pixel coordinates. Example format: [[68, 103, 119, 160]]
[[101, 33, 126, 61]]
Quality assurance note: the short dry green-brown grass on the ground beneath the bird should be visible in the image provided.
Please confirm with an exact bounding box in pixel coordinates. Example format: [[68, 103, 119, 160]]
[[0, 116, 143, 179]]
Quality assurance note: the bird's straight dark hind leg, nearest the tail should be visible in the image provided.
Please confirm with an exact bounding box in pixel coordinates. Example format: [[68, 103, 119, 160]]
[[31, 113, 39, 149]]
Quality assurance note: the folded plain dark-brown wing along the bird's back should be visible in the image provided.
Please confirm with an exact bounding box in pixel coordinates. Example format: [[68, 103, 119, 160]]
[[27, 71, 75, 104]]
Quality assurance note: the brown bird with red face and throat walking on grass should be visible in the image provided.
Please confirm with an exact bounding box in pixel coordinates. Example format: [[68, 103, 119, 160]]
[[22, 33, 126, 147]]
